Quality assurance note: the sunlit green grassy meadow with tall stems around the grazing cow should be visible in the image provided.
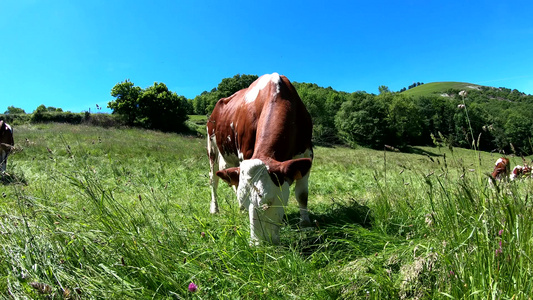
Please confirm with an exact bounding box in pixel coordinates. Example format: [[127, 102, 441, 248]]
[[0, 124, 533, 299]]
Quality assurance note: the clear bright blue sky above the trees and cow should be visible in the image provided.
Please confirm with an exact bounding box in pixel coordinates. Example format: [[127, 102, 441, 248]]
[[0, 0, 533, 113]]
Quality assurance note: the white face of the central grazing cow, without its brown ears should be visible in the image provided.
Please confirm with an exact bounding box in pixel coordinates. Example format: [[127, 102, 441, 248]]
[[237, 159, 289, 244]]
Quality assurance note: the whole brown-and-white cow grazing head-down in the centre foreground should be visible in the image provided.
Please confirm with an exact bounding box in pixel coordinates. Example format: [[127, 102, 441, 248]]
[[207, 73, 313, 244]]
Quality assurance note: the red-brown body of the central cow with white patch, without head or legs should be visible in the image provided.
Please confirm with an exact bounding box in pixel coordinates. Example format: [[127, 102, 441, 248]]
[[207, 73, 312, 161]]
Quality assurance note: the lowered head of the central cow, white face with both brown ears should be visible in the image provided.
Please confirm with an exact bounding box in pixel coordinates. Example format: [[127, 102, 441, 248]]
[[217, 158, 311, 244]]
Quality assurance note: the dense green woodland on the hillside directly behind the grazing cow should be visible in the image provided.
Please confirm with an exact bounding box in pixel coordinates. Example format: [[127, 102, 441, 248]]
[[192, 75, 533, 155]]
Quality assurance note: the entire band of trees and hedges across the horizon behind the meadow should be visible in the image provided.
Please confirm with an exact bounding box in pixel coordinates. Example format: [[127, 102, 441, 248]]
[[4, 74, 533, 155]]
